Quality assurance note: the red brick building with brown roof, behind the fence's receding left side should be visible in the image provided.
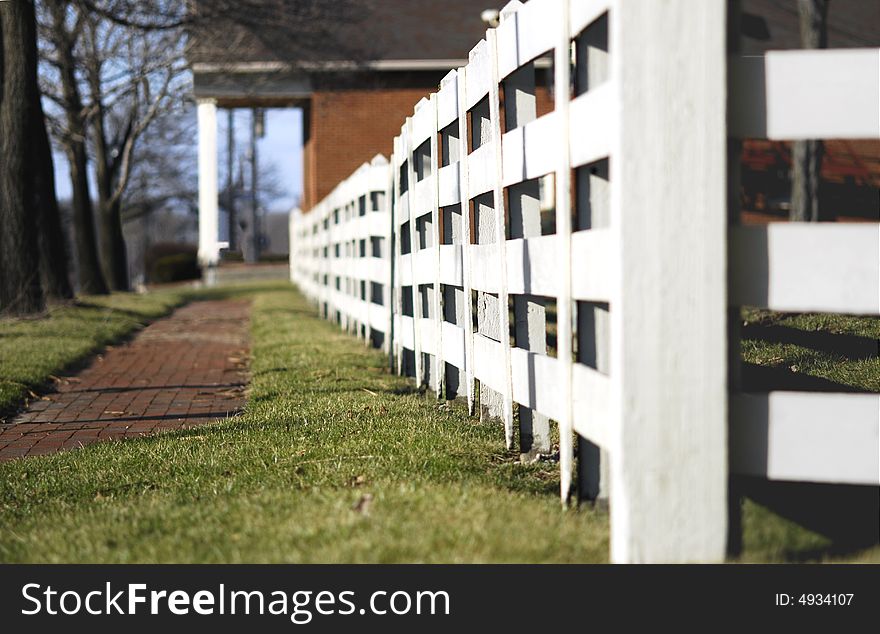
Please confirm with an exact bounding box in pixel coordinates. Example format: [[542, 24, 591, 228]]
[[189, 0, 506, 220]]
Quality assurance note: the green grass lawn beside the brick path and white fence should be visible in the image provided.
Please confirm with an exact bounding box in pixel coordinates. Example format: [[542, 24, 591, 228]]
[[0, 285, 880, 562]]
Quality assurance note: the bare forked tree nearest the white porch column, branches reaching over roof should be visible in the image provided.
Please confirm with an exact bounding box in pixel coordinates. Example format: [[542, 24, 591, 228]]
[[45, 0, 357, 290]]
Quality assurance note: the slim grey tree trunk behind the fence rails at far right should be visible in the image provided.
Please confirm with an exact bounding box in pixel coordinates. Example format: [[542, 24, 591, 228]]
[[789, 0, 829, 222]]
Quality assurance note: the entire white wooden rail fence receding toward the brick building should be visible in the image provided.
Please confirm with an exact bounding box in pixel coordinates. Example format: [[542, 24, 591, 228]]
[[291, 0, 880, 562]]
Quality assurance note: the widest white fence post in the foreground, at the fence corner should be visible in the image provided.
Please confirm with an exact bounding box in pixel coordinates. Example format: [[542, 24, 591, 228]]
[[610, 0, 727, 562]]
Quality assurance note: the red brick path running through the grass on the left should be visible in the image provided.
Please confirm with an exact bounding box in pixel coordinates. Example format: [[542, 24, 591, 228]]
[[0, 301, 250, 461]]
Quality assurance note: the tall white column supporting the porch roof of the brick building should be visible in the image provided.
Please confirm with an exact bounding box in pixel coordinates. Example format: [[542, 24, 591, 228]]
[[199, 99, 220, 266]]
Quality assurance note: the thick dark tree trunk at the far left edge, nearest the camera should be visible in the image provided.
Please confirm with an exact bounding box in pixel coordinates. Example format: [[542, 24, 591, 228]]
[[0, 0, 45, 315]]
